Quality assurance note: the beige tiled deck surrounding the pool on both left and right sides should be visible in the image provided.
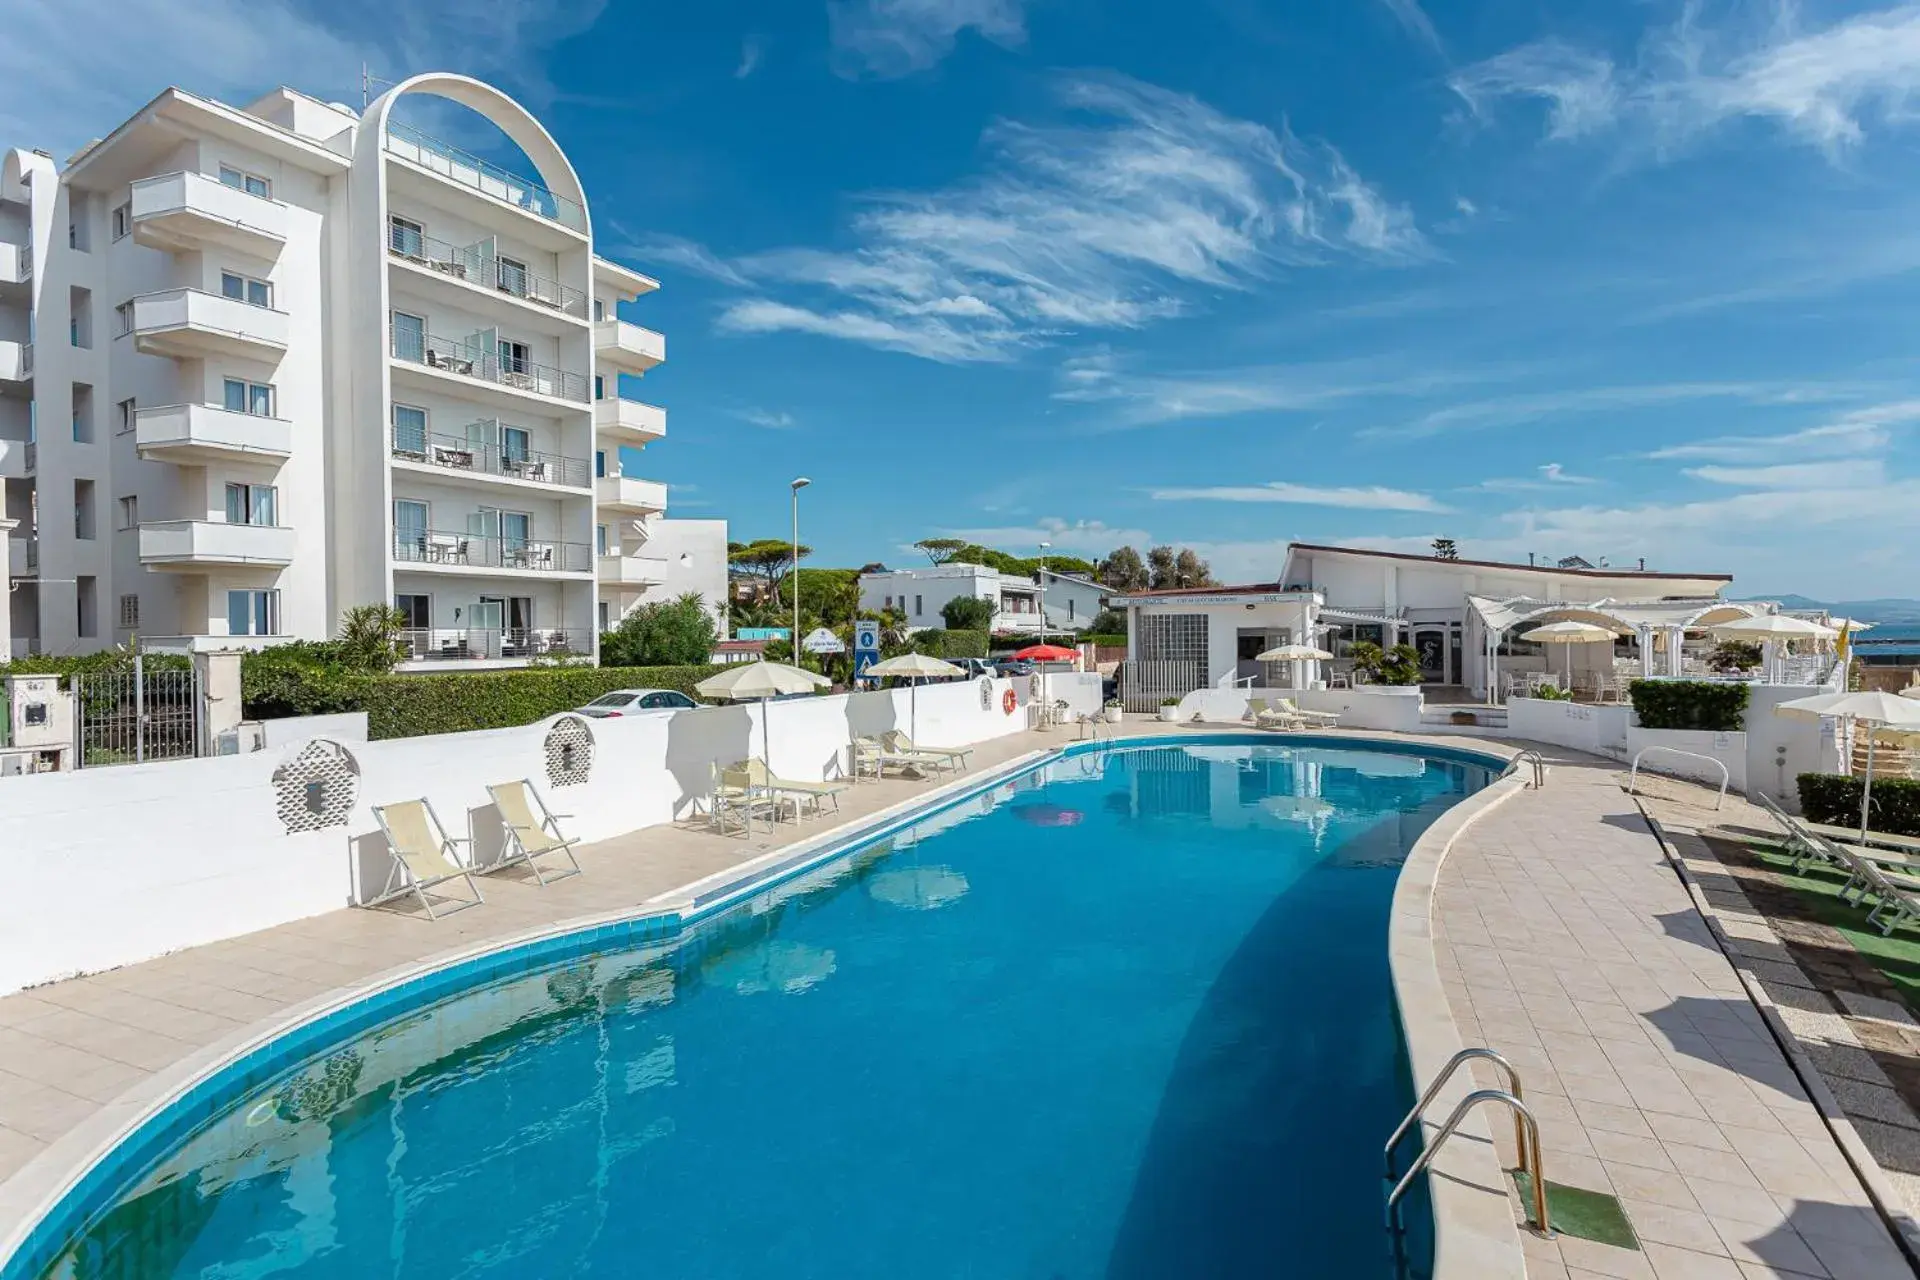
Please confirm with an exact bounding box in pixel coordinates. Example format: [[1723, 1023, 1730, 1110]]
[[0, 723, 1912, 1280]]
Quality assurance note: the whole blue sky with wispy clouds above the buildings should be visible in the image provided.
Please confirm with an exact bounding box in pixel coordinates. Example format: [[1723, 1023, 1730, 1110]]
[[11, 0, 1920, 597]]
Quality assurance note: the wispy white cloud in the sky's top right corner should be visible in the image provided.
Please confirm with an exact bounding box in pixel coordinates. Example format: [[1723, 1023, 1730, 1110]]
[[1452, 0, 1920, 155]]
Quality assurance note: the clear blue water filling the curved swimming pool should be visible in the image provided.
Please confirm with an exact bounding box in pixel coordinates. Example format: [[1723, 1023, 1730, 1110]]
[[46, 739, 1488, 1280]]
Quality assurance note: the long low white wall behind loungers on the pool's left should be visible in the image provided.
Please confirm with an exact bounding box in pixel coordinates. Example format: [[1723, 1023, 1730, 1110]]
[[0, 679, 1036, 994]]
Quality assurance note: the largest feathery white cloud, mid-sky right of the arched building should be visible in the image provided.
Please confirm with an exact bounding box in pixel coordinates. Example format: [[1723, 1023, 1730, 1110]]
[[683, 75, 1428, 363]]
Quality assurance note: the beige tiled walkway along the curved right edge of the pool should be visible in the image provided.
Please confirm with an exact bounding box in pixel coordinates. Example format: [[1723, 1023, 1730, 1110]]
[[1434, 756, 1912, 1280]]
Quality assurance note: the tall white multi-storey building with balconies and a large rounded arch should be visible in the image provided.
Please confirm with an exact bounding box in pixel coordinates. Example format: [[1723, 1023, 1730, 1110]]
[[0, 75, 726, 670]]
